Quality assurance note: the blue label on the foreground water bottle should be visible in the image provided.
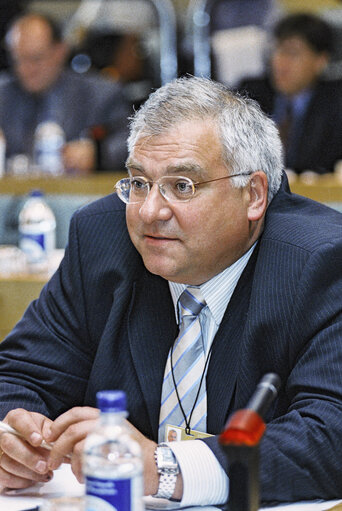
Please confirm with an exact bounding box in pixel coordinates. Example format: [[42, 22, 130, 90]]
[[85, 476, 139, 511]]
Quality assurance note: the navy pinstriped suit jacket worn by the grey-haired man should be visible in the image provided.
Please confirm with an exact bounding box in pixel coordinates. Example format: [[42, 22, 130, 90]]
[[0, 178, 342, 501]]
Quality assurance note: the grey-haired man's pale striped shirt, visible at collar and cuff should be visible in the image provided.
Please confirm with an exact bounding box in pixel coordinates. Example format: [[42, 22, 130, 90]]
[[168, 243, 256, 506]]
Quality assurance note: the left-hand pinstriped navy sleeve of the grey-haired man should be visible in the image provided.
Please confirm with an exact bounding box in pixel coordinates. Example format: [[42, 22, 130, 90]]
[[0, 212, 93, 418]]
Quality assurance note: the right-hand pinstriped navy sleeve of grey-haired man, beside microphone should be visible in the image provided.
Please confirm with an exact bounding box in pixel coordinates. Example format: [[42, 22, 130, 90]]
[[205, 242, 342, 502]]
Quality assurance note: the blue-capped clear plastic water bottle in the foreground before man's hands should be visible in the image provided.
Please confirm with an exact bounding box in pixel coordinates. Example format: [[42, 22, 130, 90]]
[[83, 390, 144, 511]]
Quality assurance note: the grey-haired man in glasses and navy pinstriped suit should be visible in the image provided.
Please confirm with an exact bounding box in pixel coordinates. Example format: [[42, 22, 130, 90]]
[[0, 77, 342, 505]]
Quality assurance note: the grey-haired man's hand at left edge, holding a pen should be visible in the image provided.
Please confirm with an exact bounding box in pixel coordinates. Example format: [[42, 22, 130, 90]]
[[0, 408, 53, 488]]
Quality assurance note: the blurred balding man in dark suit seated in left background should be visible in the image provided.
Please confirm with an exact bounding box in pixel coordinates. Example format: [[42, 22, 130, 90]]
[[0, 14, 130, 173]]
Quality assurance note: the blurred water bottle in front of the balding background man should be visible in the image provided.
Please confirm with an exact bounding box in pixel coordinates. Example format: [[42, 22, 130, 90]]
[[33, 121, 65, 176]]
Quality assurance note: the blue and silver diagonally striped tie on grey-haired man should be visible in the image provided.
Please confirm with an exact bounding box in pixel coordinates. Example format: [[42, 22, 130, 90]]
[[159, 287, 207, 442]]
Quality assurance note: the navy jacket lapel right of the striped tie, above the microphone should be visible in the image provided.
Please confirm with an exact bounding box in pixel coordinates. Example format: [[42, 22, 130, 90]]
[[207, 246, 259, 434]]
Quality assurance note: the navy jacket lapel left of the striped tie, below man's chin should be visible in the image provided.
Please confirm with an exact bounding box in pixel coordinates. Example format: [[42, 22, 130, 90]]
[[128, 270, 177, 438]]
